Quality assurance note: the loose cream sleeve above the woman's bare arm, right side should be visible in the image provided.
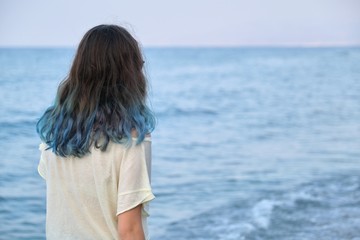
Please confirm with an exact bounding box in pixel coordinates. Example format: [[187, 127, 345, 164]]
[[116, 139, 155, 216]]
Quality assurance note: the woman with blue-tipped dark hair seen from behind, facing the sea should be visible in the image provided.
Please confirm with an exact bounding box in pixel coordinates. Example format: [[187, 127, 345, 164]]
[[37, 25, 155, 240]]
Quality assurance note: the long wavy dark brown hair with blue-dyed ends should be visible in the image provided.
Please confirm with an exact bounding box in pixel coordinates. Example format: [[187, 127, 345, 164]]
[[36, 25, 155, 157]]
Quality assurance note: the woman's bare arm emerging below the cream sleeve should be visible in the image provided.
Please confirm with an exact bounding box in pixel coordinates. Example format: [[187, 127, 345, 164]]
[[118, 204, 145, 240]]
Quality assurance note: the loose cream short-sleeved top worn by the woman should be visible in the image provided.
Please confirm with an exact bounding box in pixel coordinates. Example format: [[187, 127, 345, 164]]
[[38, 137, 155, 240]]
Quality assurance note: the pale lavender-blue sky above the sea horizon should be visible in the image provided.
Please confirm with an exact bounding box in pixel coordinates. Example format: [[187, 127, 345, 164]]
[[0, 0, 360, 47]]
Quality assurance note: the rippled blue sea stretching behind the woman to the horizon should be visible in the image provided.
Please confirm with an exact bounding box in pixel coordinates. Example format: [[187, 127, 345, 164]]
[[0, 47, 360, 240]]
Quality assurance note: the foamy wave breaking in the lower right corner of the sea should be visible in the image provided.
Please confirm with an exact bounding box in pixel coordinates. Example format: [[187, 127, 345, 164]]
[[155, 174, 360, 240]]
